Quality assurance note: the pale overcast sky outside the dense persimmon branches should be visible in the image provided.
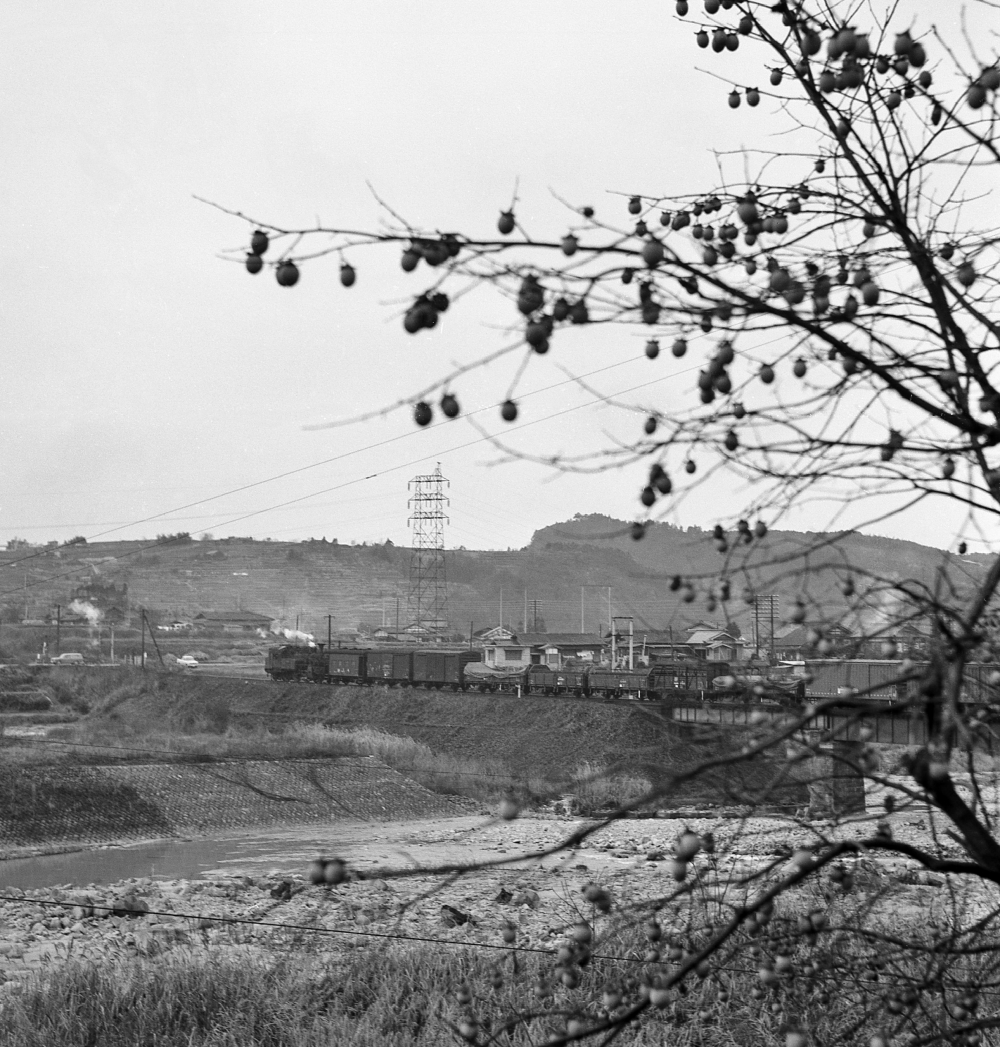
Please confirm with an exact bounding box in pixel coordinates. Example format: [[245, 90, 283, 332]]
[[0, 0, 980, 548]]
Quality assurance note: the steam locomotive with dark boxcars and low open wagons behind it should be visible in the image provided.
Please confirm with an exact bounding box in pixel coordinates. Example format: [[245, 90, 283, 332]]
[[264, 644, 805, 703]]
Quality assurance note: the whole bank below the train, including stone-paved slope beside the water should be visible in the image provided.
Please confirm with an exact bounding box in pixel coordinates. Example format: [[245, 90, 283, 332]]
[[0, 672, 809, 856]]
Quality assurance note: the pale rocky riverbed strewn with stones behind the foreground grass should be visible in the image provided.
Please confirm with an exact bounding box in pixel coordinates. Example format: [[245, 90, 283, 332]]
[[0, 817, 988, 993]]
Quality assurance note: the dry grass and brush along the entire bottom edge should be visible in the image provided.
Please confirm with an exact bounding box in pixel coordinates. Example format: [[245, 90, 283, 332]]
[[0, 897, 997, 1047]]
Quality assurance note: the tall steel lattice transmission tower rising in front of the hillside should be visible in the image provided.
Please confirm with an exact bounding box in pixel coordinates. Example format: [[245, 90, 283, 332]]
[[407, 462, 451, 636]]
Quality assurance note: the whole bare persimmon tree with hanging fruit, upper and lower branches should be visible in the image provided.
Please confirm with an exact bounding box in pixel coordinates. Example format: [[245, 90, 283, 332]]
[[203, 0, 1000, 1047]]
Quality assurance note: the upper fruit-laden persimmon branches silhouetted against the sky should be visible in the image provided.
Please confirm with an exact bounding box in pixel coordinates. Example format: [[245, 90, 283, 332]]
[[218, 0, 1000, 561]]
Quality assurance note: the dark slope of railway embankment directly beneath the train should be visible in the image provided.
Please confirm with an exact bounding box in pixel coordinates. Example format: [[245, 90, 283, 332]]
[[90, 674, 808, 806]]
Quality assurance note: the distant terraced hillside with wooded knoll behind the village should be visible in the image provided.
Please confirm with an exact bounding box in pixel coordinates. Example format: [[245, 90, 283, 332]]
[[0, 515, 991, 638]]
